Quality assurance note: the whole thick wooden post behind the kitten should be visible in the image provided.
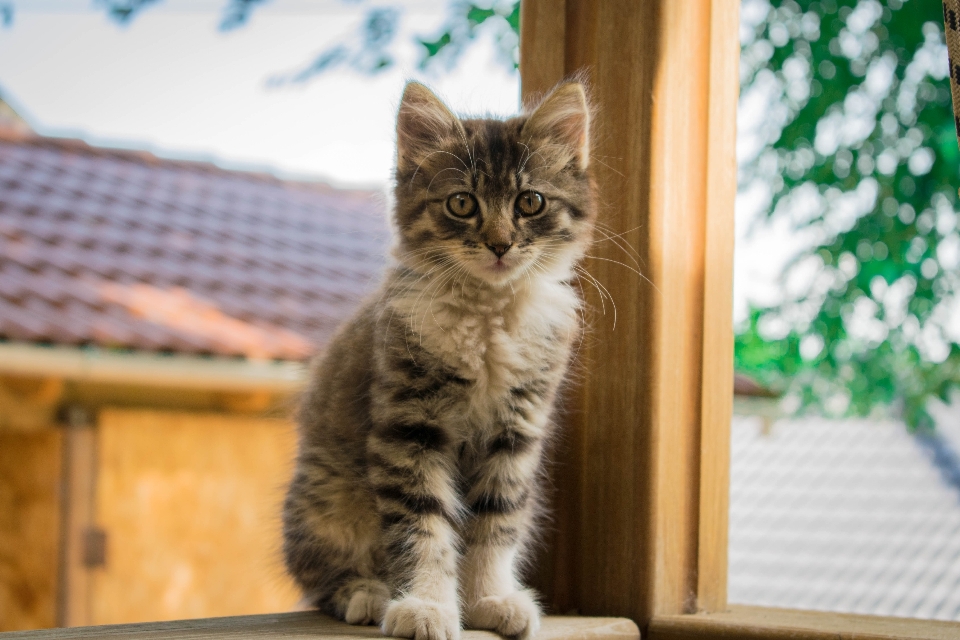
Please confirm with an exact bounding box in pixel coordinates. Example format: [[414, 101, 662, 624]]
[[520, 0, 738, 628]]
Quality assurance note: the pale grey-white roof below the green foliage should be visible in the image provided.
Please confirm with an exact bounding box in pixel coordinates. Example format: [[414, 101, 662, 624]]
[[728, 416, 960, 620]]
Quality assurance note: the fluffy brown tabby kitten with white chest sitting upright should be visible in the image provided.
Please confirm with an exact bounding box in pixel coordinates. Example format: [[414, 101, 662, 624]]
[[283, 82, 596, 640]]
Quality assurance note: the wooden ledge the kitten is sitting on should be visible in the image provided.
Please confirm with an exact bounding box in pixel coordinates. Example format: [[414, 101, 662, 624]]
[[0, 611, 640, 640]]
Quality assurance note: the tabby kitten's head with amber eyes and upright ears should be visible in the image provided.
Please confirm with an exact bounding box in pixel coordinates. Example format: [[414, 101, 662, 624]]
[[395, 82, 596, 285]]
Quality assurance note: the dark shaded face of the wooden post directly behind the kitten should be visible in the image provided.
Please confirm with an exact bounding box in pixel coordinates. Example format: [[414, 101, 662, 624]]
[[564, 2, 658, 626]]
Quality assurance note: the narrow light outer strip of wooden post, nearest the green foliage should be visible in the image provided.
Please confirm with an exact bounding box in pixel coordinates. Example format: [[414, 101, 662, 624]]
[[697, 0, 740, 611]]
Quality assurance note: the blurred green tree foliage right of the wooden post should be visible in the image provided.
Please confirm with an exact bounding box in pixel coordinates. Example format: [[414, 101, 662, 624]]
[[736, 0, 960, 428]]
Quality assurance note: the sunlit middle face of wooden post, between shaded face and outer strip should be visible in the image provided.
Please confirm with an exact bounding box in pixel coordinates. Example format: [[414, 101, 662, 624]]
[[637, 0, 710, 619]]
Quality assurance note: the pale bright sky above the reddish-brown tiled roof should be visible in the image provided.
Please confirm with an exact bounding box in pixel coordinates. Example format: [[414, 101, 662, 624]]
[[0, 0, 520, 186]]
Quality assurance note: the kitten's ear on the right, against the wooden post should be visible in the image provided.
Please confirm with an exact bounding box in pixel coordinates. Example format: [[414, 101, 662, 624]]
[[523, 82, 590, 169]]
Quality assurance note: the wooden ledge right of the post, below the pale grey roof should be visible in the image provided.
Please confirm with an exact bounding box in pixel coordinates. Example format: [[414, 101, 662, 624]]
[[647, 606, 960, 640]]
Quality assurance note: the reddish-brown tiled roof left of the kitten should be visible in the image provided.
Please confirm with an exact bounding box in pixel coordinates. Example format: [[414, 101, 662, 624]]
[[0, 130, 388, 360]]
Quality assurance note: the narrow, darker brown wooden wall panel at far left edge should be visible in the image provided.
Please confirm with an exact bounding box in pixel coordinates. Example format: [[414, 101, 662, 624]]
[[0, 427, 62, 631]]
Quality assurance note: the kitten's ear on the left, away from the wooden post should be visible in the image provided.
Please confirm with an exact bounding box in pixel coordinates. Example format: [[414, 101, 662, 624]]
[[397, 82, 463, 170]]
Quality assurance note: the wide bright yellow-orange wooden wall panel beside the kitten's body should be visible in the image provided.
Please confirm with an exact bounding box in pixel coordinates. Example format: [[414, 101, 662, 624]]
[[92, 409, 298, 624]]
